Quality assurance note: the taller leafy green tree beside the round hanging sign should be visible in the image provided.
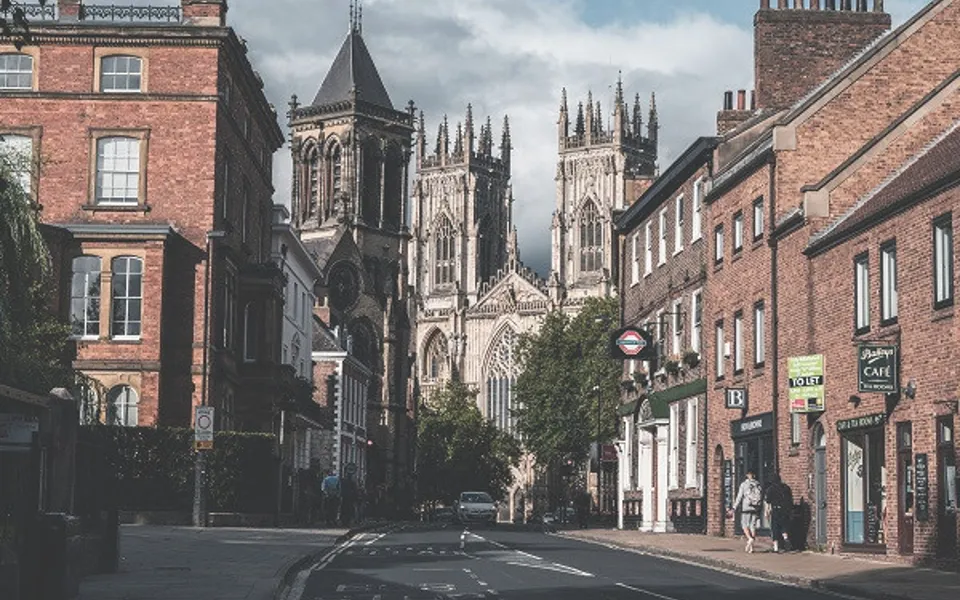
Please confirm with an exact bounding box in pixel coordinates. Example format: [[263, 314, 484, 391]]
[[516, 298, 623, 464]]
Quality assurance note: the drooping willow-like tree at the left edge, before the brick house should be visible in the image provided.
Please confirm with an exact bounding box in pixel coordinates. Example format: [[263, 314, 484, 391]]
[[0, 135, 76, 394]]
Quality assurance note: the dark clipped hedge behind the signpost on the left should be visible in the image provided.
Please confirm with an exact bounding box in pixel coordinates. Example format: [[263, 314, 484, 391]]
[[80, 425, 278, 513]]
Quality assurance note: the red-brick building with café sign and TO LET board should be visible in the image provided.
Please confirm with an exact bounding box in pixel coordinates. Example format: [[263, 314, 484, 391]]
[[706, 0, 960, 561]]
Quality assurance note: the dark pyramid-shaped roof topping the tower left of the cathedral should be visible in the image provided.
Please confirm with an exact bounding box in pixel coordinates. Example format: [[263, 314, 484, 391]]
[[313, 30, 393, 110]]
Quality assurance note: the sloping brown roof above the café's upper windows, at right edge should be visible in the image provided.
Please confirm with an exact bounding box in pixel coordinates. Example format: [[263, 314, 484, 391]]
[[807, 120, 960, 253]]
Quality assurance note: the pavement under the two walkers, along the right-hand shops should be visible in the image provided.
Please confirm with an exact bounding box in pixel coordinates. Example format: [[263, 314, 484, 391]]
[[553, 529, 960, 600]]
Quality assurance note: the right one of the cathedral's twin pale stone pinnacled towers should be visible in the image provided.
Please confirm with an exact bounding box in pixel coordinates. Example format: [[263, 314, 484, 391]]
[[550, 79, 659, 307]]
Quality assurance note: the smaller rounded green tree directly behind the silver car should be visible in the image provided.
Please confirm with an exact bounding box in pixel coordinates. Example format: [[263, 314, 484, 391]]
[[417, 380, 520, 505]]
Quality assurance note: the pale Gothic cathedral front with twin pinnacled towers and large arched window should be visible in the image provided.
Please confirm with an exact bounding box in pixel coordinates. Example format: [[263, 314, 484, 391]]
[[408, 81, 657, 518]]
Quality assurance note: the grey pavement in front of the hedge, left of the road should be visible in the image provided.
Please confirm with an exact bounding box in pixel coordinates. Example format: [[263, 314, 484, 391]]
[[78, 525, 360, 600]]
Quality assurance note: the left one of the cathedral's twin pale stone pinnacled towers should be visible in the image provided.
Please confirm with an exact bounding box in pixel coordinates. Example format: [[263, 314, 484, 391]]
[[410, 105, 515, 305]]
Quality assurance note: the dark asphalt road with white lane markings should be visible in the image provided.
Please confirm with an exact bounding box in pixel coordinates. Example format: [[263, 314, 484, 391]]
[[287, 524, 844, 600]]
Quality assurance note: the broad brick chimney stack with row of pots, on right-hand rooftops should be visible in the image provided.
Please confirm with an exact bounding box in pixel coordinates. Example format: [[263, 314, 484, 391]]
[[753, 0, 891, 108]]
